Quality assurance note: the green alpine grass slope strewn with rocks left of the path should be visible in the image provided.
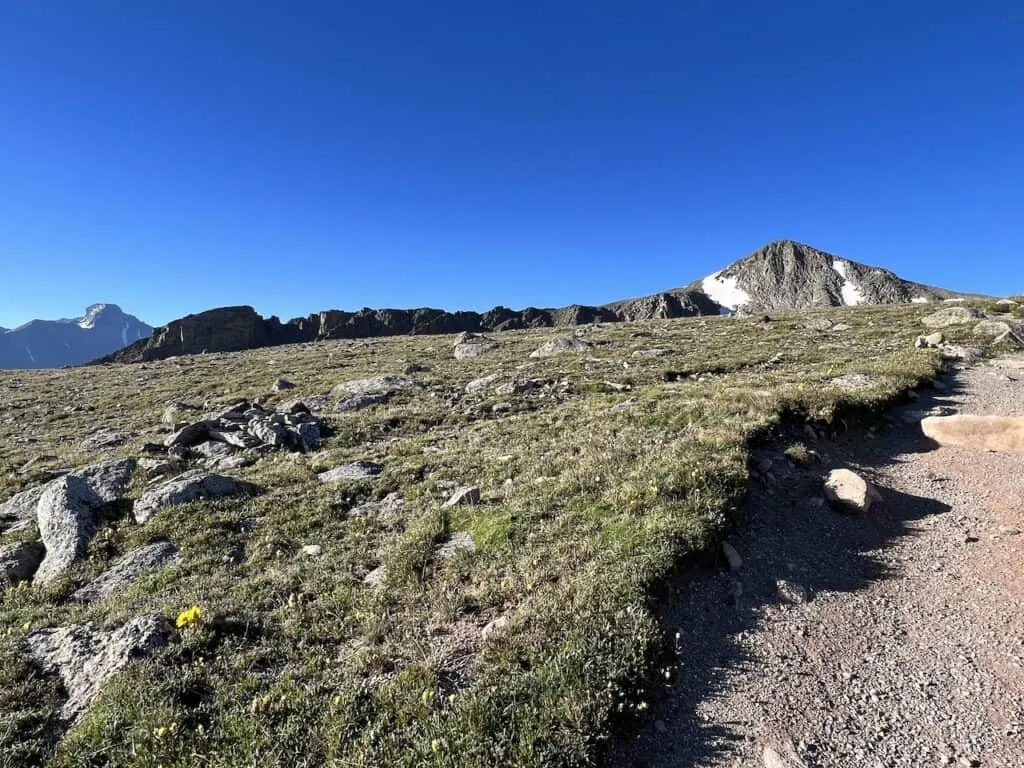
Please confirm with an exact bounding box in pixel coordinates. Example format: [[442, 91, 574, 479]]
[[0, 306, 995, 768]]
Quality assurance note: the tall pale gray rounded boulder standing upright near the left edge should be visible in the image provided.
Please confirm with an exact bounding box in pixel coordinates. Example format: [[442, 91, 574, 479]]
[[35, 475, 103, 584]]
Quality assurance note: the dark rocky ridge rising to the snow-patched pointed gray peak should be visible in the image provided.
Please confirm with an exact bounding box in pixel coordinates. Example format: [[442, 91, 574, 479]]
[[95, 241, 955, 362]]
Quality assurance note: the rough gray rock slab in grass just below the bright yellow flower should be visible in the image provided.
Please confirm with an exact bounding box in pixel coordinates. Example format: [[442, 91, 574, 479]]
[[27, 614, 171, 724]]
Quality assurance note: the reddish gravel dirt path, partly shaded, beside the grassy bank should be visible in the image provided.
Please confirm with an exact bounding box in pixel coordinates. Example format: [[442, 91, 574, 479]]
[[609, 358, 1024, 768]]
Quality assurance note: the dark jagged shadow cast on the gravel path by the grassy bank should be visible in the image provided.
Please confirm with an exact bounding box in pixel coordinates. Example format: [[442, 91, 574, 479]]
[[606, 380, 956, 768]]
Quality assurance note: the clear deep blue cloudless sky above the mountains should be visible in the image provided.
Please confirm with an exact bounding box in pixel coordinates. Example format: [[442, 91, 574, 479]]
[[0, 0, 1024, 327]]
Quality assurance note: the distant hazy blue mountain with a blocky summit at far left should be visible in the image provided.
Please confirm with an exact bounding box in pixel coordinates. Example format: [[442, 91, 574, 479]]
[[0, 304, 153, 369]]
